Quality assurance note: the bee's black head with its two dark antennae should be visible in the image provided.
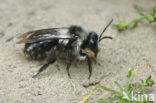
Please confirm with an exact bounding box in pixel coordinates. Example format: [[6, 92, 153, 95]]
[[87, 19, 113, 57]]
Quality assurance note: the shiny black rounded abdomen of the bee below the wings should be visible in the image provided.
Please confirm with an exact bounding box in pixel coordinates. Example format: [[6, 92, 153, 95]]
[[24, 40, 57, 59]]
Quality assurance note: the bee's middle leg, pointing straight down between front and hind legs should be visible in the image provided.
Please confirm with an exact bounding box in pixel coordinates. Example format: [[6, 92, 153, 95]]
[[66, 51, 73, 78]]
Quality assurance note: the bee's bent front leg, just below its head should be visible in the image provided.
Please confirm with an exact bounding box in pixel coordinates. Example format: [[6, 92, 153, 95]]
[[80, 51, 92, 79]]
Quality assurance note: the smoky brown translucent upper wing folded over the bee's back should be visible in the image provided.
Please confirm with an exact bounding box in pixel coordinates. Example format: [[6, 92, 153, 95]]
[[17, 27, 68, 44]]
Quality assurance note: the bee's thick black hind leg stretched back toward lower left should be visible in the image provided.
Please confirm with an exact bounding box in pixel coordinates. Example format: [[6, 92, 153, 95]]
[[33, 47, 57, 78]]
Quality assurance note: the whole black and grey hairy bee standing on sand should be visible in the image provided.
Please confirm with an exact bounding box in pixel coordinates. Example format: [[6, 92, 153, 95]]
[[17, 19, 113, 78]]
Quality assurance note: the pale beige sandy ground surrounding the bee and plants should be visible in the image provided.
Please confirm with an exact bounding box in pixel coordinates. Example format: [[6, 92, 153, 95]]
[[0, 0, 156, 103]]
